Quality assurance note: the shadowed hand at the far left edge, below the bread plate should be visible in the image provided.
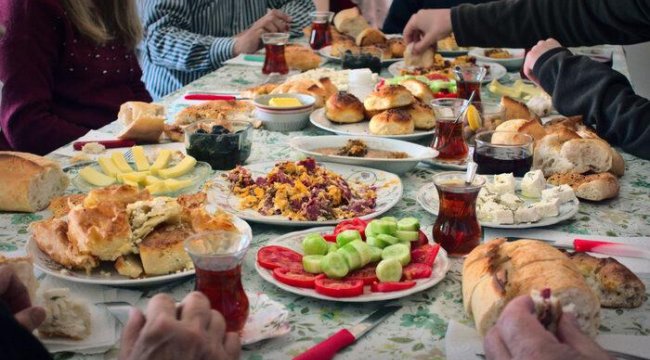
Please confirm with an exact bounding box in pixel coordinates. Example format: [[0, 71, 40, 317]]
[[0, 266, 45, 331]]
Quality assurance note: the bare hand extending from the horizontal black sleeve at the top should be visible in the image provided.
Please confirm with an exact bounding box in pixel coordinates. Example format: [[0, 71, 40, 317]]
[[404, 9, 452, 54]]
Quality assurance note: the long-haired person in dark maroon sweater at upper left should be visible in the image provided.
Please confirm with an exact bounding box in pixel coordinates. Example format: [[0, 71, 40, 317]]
[[0, 0, 151, 155]]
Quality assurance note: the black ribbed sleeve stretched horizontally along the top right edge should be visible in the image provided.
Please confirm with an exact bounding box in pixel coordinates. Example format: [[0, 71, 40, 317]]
[[451, 0, 650, 48]]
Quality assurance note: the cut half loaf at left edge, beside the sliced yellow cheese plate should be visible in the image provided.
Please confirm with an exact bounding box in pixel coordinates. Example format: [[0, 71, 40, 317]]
[[0, 151, 70, 212]]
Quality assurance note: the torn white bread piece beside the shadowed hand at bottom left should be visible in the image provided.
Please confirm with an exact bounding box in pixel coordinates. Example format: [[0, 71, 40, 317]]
[[38, 288, 91, 340]]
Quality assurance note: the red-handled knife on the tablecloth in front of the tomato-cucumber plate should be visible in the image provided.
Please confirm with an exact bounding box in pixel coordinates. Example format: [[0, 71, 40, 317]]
[[294, 305, 402, 360]]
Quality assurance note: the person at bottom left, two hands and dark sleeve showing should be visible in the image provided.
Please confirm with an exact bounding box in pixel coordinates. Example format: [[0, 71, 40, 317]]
[[0, 265, 241, 360]]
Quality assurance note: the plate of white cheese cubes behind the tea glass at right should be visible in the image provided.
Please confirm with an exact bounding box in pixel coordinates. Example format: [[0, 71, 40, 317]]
[[416, 170, 580, 229]]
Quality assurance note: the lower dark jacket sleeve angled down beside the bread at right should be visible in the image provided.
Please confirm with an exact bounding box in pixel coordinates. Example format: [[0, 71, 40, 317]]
[[533, 48, 650, 160]]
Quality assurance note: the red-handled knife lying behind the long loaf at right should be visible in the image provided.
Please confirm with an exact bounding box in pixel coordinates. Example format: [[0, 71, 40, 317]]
[[506, 236, 650, 260]]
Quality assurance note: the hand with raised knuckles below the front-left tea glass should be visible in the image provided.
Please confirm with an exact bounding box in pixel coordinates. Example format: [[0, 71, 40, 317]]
[[120, 292, 241, 360]]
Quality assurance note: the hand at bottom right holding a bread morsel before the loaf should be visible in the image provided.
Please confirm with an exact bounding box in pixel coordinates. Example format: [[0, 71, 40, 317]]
[[483, 296, 609, 360]]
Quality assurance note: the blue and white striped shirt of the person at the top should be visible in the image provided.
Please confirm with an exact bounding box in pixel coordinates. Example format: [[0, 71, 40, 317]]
[[140, 0, 314, 99]]
